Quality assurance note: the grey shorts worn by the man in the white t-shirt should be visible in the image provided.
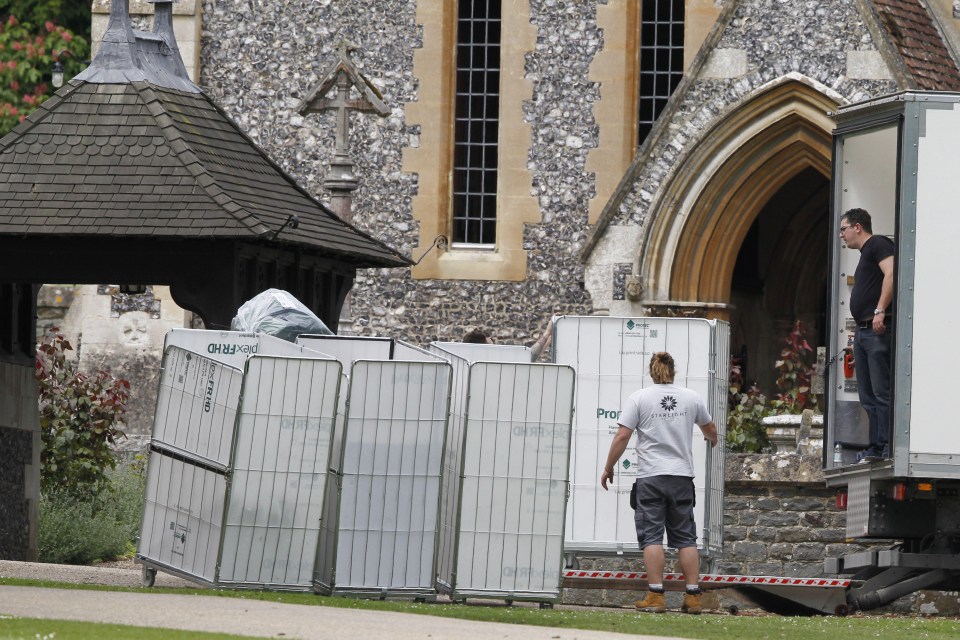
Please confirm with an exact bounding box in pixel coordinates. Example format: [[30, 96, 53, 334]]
[[634, 476, 697, 549]]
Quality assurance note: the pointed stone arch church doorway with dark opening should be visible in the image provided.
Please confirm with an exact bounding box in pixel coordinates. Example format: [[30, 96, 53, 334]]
[[639, 77, 840, 394]]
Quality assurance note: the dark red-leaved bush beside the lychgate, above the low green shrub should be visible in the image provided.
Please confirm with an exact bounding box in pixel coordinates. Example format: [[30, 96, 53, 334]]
[[35, 329, 130, 501]]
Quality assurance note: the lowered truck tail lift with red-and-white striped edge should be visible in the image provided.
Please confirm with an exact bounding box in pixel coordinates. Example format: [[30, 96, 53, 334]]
[[563, 569, 860, 616]]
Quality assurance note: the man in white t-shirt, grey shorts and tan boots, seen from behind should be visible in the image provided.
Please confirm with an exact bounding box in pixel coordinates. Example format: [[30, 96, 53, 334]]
[[600, 351, 717, 613]]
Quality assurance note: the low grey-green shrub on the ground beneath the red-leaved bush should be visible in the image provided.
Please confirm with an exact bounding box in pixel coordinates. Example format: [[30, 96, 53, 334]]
[[37, 465, 144, 564]]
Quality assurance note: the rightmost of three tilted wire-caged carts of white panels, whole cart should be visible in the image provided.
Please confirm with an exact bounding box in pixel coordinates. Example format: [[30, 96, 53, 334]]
[[430, 342, 575, 603]]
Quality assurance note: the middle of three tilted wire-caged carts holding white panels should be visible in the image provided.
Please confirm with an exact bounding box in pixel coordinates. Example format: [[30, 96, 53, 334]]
[[298, 336, 451, 597]]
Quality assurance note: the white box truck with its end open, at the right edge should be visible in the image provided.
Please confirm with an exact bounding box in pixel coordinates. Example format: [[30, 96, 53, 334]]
[[824, 91, 960, 609]]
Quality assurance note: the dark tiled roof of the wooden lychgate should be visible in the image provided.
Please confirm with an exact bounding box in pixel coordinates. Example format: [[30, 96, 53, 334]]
[[0, 81, 409, 266]]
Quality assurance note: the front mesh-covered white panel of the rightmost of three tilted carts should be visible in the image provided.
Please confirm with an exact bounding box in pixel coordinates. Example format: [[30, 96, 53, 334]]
[[455, 363, 574, 598]]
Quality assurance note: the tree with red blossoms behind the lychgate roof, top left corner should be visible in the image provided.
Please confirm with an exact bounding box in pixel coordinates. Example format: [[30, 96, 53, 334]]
[[0, 9, 89, 136]]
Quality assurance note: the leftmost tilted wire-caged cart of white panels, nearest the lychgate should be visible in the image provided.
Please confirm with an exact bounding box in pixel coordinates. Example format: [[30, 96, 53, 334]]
[[137, 330, 341, 591]]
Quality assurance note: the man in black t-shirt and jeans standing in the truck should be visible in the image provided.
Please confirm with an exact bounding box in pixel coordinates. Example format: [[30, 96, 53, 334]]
[[840, 209, 894, 462]]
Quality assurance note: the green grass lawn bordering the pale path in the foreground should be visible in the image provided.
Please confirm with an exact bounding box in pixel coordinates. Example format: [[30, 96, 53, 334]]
[[0, 579, 960, 640]]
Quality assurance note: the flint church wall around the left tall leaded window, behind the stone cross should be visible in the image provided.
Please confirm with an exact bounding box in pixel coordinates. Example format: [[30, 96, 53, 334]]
[[200, 0, 603, 344]]
